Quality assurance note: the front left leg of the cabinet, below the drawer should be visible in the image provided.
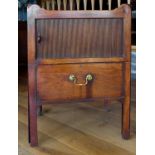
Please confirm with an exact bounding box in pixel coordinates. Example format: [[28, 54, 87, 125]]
[[28, 103, 38, 146]]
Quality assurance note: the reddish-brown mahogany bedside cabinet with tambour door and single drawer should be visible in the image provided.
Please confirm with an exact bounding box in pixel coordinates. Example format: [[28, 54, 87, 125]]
[[28, 5, 131, 146]]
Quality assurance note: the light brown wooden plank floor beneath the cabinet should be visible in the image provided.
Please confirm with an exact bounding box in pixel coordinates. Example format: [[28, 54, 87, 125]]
[[18, 73, 136, 155]]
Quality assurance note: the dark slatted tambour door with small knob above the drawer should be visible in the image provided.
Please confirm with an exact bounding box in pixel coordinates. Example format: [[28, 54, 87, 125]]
[[36, 18, 124, 59]]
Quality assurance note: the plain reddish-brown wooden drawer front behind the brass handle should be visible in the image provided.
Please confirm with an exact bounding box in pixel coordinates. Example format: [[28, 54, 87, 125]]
[[37, 63, 122, 101]]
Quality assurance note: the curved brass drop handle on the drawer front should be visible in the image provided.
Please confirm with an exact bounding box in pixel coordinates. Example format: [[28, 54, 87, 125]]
[[69, 74, 93, 86]]
